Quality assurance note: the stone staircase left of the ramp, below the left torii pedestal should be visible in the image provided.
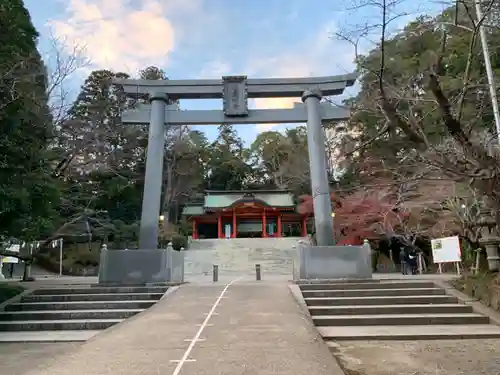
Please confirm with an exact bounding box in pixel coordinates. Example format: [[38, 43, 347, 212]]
[[0, 286, 167, 341]]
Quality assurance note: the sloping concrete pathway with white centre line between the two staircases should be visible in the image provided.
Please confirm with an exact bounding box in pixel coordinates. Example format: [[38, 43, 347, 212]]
[[16, 281, 343, 375]]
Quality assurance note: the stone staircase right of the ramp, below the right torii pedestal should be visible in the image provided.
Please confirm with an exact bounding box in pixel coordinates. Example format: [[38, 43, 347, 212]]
[[298, 280, 500, 345]]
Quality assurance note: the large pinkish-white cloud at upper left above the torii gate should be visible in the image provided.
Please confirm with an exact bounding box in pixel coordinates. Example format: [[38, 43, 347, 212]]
[[49, 0, 200, 73]]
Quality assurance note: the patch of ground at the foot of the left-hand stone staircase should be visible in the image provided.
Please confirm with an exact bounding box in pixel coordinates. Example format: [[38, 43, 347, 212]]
[[0, 343, 80, 375]]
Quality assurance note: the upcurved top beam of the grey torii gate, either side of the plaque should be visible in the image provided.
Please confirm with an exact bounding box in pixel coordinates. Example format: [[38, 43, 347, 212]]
[[113, 73, 358, 100]]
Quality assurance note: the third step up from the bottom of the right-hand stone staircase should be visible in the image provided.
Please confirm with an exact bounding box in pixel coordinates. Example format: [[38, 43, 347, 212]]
[[309, 303, 474, 315]]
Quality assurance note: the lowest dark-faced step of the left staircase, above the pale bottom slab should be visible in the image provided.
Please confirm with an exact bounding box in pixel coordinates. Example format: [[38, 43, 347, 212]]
[[0, 319, 123, 332]]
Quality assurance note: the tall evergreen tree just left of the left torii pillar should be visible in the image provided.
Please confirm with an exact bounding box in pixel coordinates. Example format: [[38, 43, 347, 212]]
[[59, 70, 147, 223]]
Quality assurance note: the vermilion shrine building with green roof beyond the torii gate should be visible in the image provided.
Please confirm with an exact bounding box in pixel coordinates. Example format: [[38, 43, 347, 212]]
[[182, 190, 308, 239]]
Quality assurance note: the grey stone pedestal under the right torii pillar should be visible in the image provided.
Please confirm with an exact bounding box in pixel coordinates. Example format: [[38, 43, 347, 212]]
[[299, 243, 372, 280]]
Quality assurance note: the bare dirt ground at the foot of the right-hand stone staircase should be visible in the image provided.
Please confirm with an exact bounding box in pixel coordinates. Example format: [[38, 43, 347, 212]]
[[333, 340, 500, 375]]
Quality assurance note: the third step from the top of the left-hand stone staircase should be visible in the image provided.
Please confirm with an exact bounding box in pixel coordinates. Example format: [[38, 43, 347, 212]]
[[5, 300, 157, 311]]
